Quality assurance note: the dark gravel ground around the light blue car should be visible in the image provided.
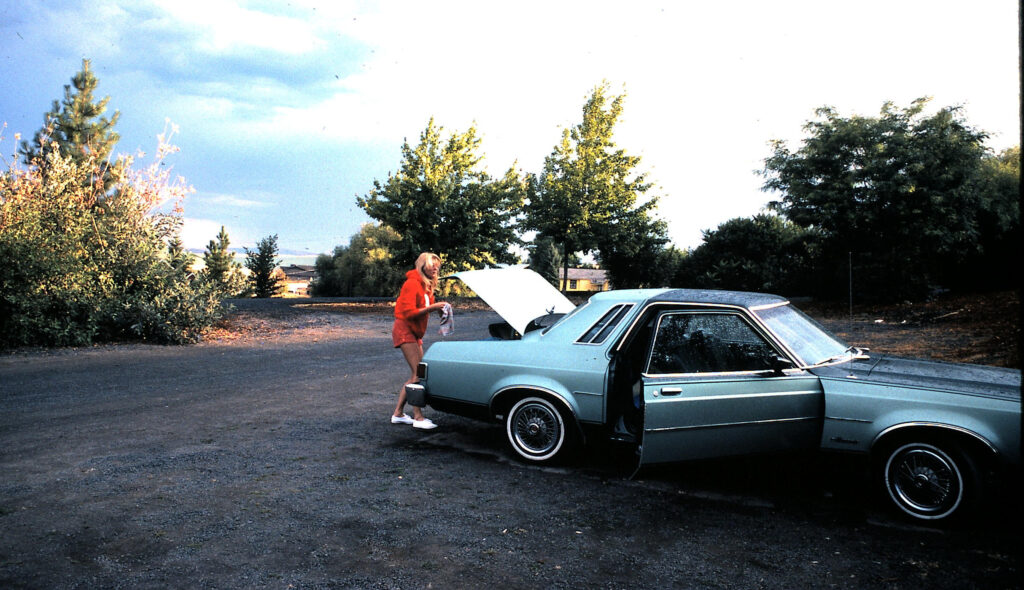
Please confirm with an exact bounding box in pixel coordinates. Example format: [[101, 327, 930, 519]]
[[0, 294, 1022, 590]]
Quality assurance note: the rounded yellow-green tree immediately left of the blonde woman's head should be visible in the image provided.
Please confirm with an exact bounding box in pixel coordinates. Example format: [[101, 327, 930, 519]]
[[310, 223, 407, 297]]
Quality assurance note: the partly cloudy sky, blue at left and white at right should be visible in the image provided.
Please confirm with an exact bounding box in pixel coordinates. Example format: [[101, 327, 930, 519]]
[[0, 0, 1021, 254]]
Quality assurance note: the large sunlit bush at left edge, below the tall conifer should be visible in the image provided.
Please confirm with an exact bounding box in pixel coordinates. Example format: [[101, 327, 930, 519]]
[[0, 127, 220, 347]]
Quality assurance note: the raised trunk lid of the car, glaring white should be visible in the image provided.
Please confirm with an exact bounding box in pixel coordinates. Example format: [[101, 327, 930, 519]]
[[445, 266, 575, 334]]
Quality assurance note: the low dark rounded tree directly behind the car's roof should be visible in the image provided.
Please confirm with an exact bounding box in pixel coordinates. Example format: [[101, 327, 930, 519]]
[[680, 214, 814, 294]]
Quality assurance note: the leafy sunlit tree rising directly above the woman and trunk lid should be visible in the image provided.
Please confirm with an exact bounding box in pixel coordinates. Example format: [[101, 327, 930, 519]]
[[357, 119, 525, 269]]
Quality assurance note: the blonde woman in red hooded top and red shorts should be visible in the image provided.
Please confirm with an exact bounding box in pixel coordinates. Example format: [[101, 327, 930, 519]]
[[391, 252, 444, 430]]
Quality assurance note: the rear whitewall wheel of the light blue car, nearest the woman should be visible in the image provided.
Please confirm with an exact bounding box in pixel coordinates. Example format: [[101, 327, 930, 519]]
[[505, 397, 567, 463]]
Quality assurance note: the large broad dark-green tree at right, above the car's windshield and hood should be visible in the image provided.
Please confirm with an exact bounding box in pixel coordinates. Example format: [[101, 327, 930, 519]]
[[762, 98, 987, 300]]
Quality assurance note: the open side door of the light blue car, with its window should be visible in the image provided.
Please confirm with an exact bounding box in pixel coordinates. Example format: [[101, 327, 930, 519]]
[[640, 310, 824, 464]]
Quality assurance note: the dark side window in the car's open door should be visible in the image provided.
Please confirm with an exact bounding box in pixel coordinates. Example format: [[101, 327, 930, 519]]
[[646, 312, 778, 375]]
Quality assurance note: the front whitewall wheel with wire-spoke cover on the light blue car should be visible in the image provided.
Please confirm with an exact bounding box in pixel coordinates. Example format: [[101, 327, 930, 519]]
[[882, 441, 978, 521]]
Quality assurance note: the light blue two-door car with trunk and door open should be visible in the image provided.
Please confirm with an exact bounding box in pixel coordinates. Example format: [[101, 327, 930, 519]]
[[411, 267, 1021, 521]]
